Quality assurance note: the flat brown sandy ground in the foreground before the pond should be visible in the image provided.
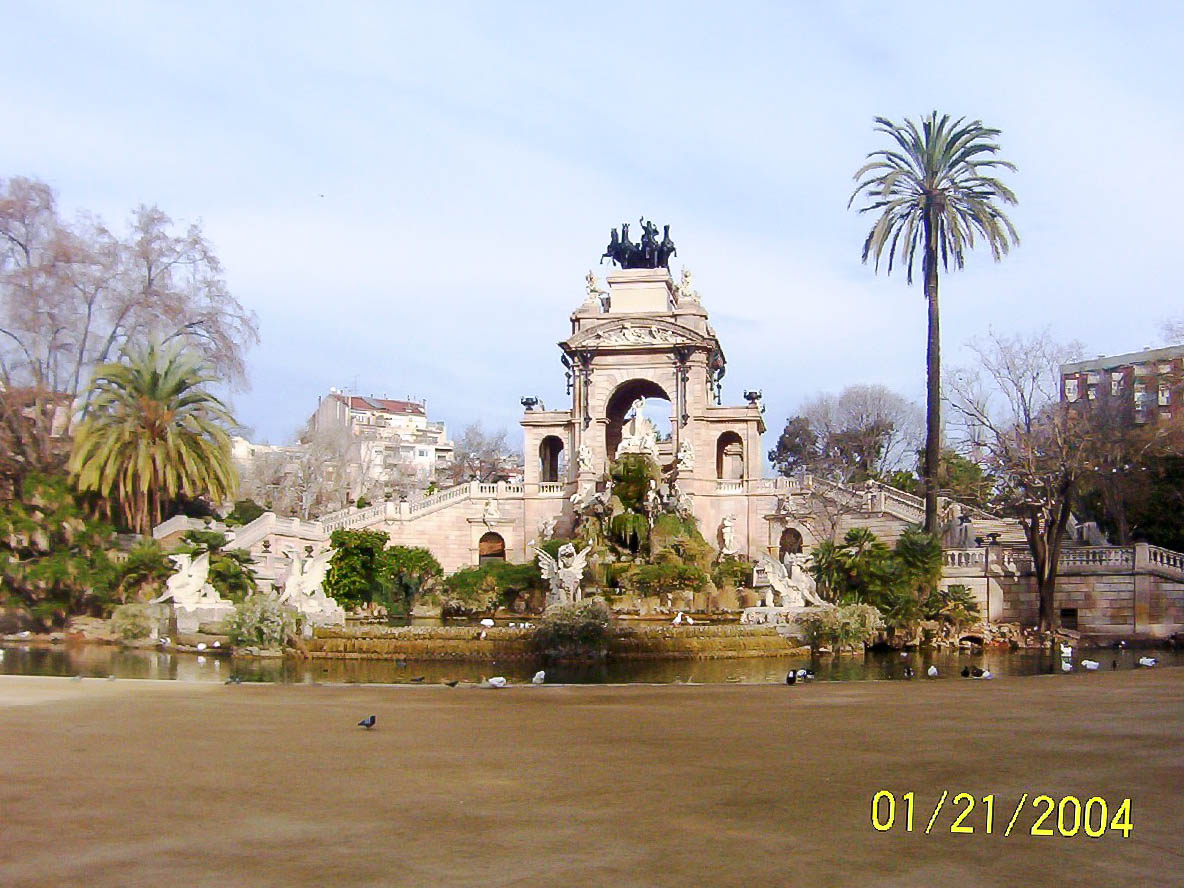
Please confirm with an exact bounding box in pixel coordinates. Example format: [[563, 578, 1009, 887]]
[[0, 669, 1184, 888]]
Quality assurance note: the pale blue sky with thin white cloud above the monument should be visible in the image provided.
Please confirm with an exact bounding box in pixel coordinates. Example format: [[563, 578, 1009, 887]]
[[0, 0, 1184, 459]]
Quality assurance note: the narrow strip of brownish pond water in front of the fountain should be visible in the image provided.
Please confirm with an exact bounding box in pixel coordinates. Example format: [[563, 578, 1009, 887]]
[[0, 645, 1184, 684]]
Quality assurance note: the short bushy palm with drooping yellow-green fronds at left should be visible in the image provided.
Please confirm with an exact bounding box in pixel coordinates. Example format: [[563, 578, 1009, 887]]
[[70, 345, 238, 535]]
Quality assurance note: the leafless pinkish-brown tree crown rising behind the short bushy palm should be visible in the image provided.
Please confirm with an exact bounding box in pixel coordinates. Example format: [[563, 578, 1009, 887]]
[[0, 178, 258, 414]]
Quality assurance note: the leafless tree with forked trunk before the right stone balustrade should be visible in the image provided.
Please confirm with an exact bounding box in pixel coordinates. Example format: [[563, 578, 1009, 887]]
[[947, 330, 1089, 630]]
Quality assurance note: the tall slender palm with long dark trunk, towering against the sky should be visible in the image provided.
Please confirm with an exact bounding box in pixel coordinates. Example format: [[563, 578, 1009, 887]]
[[847, 111, 1019, 533]]
